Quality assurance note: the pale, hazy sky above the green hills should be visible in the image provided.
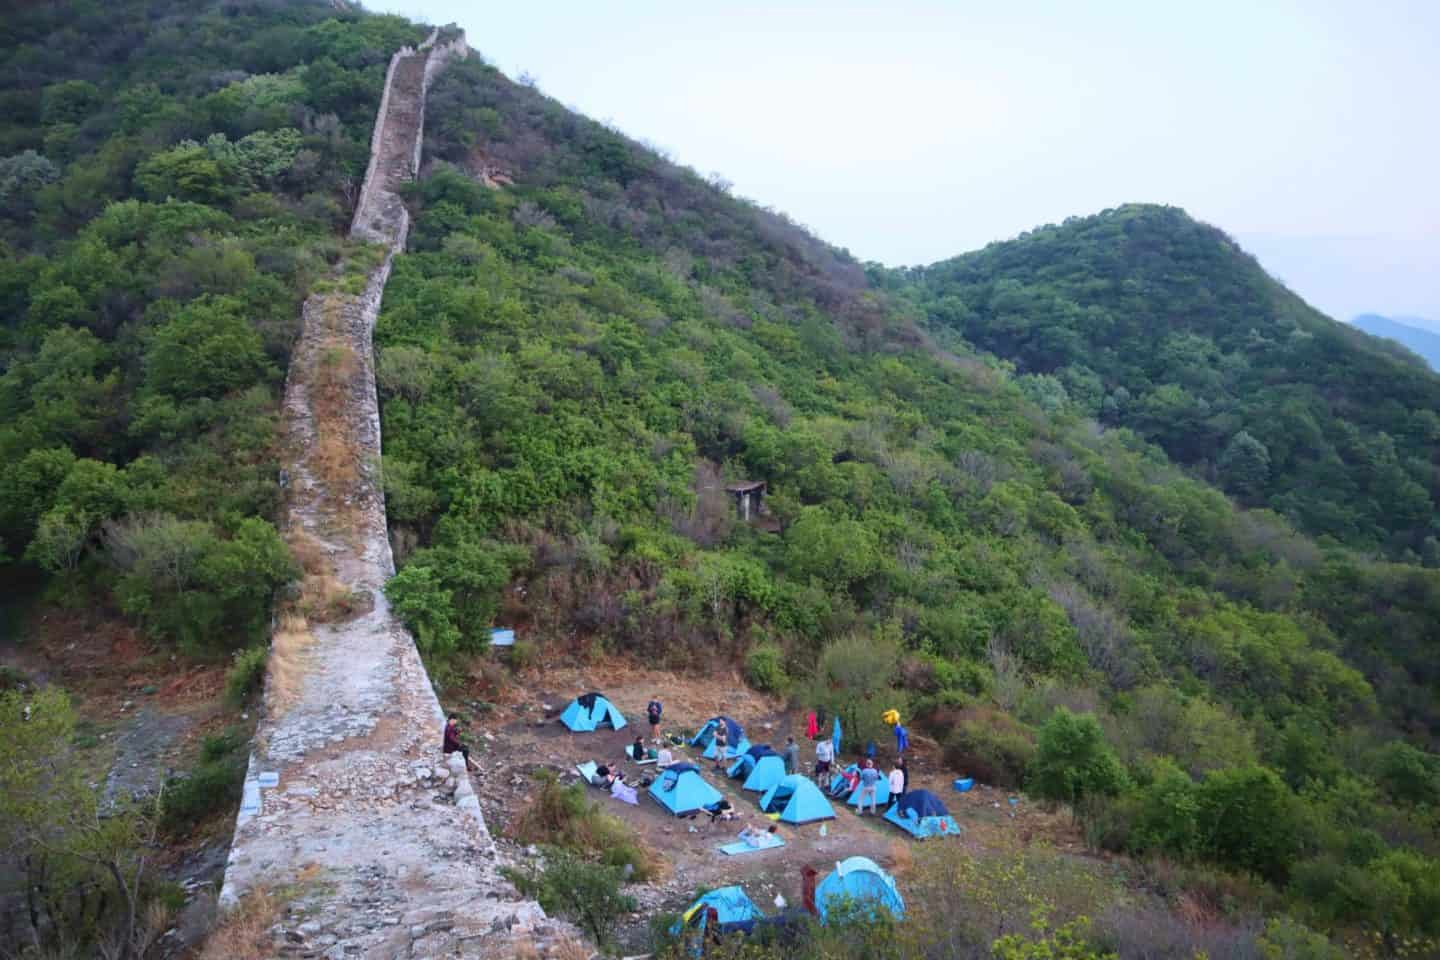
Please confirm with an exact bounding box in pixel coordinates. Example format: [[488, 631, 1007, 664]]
[[373, 0, 1440, 320]]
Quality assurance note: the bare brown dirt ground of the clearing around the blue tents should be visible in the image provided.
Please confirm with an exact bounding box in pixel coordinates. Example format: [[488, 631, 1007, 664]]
[[456, 661, 1083, 951]]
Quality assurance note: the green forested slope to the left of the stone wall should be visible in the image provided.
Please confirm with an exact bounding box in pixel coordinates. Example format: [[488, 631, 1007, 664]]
[[0, 1, 423, 652]]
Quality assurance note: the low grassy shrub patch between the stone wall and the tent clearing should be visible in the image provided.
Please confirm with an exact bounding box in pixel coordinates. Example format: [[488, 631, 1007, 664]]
[[510, 773, 661, 881]]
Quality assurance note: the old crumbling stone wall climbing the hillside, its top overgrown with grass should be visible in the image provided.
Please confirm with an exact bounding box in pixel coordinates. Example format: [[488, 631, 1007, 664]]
[[220, 32, 569, 960]]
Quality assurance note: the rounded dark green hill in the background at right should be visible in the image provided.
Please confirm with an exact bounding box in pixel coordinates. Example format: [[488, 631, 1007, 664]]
[[914, 206, 1440, 556]]
